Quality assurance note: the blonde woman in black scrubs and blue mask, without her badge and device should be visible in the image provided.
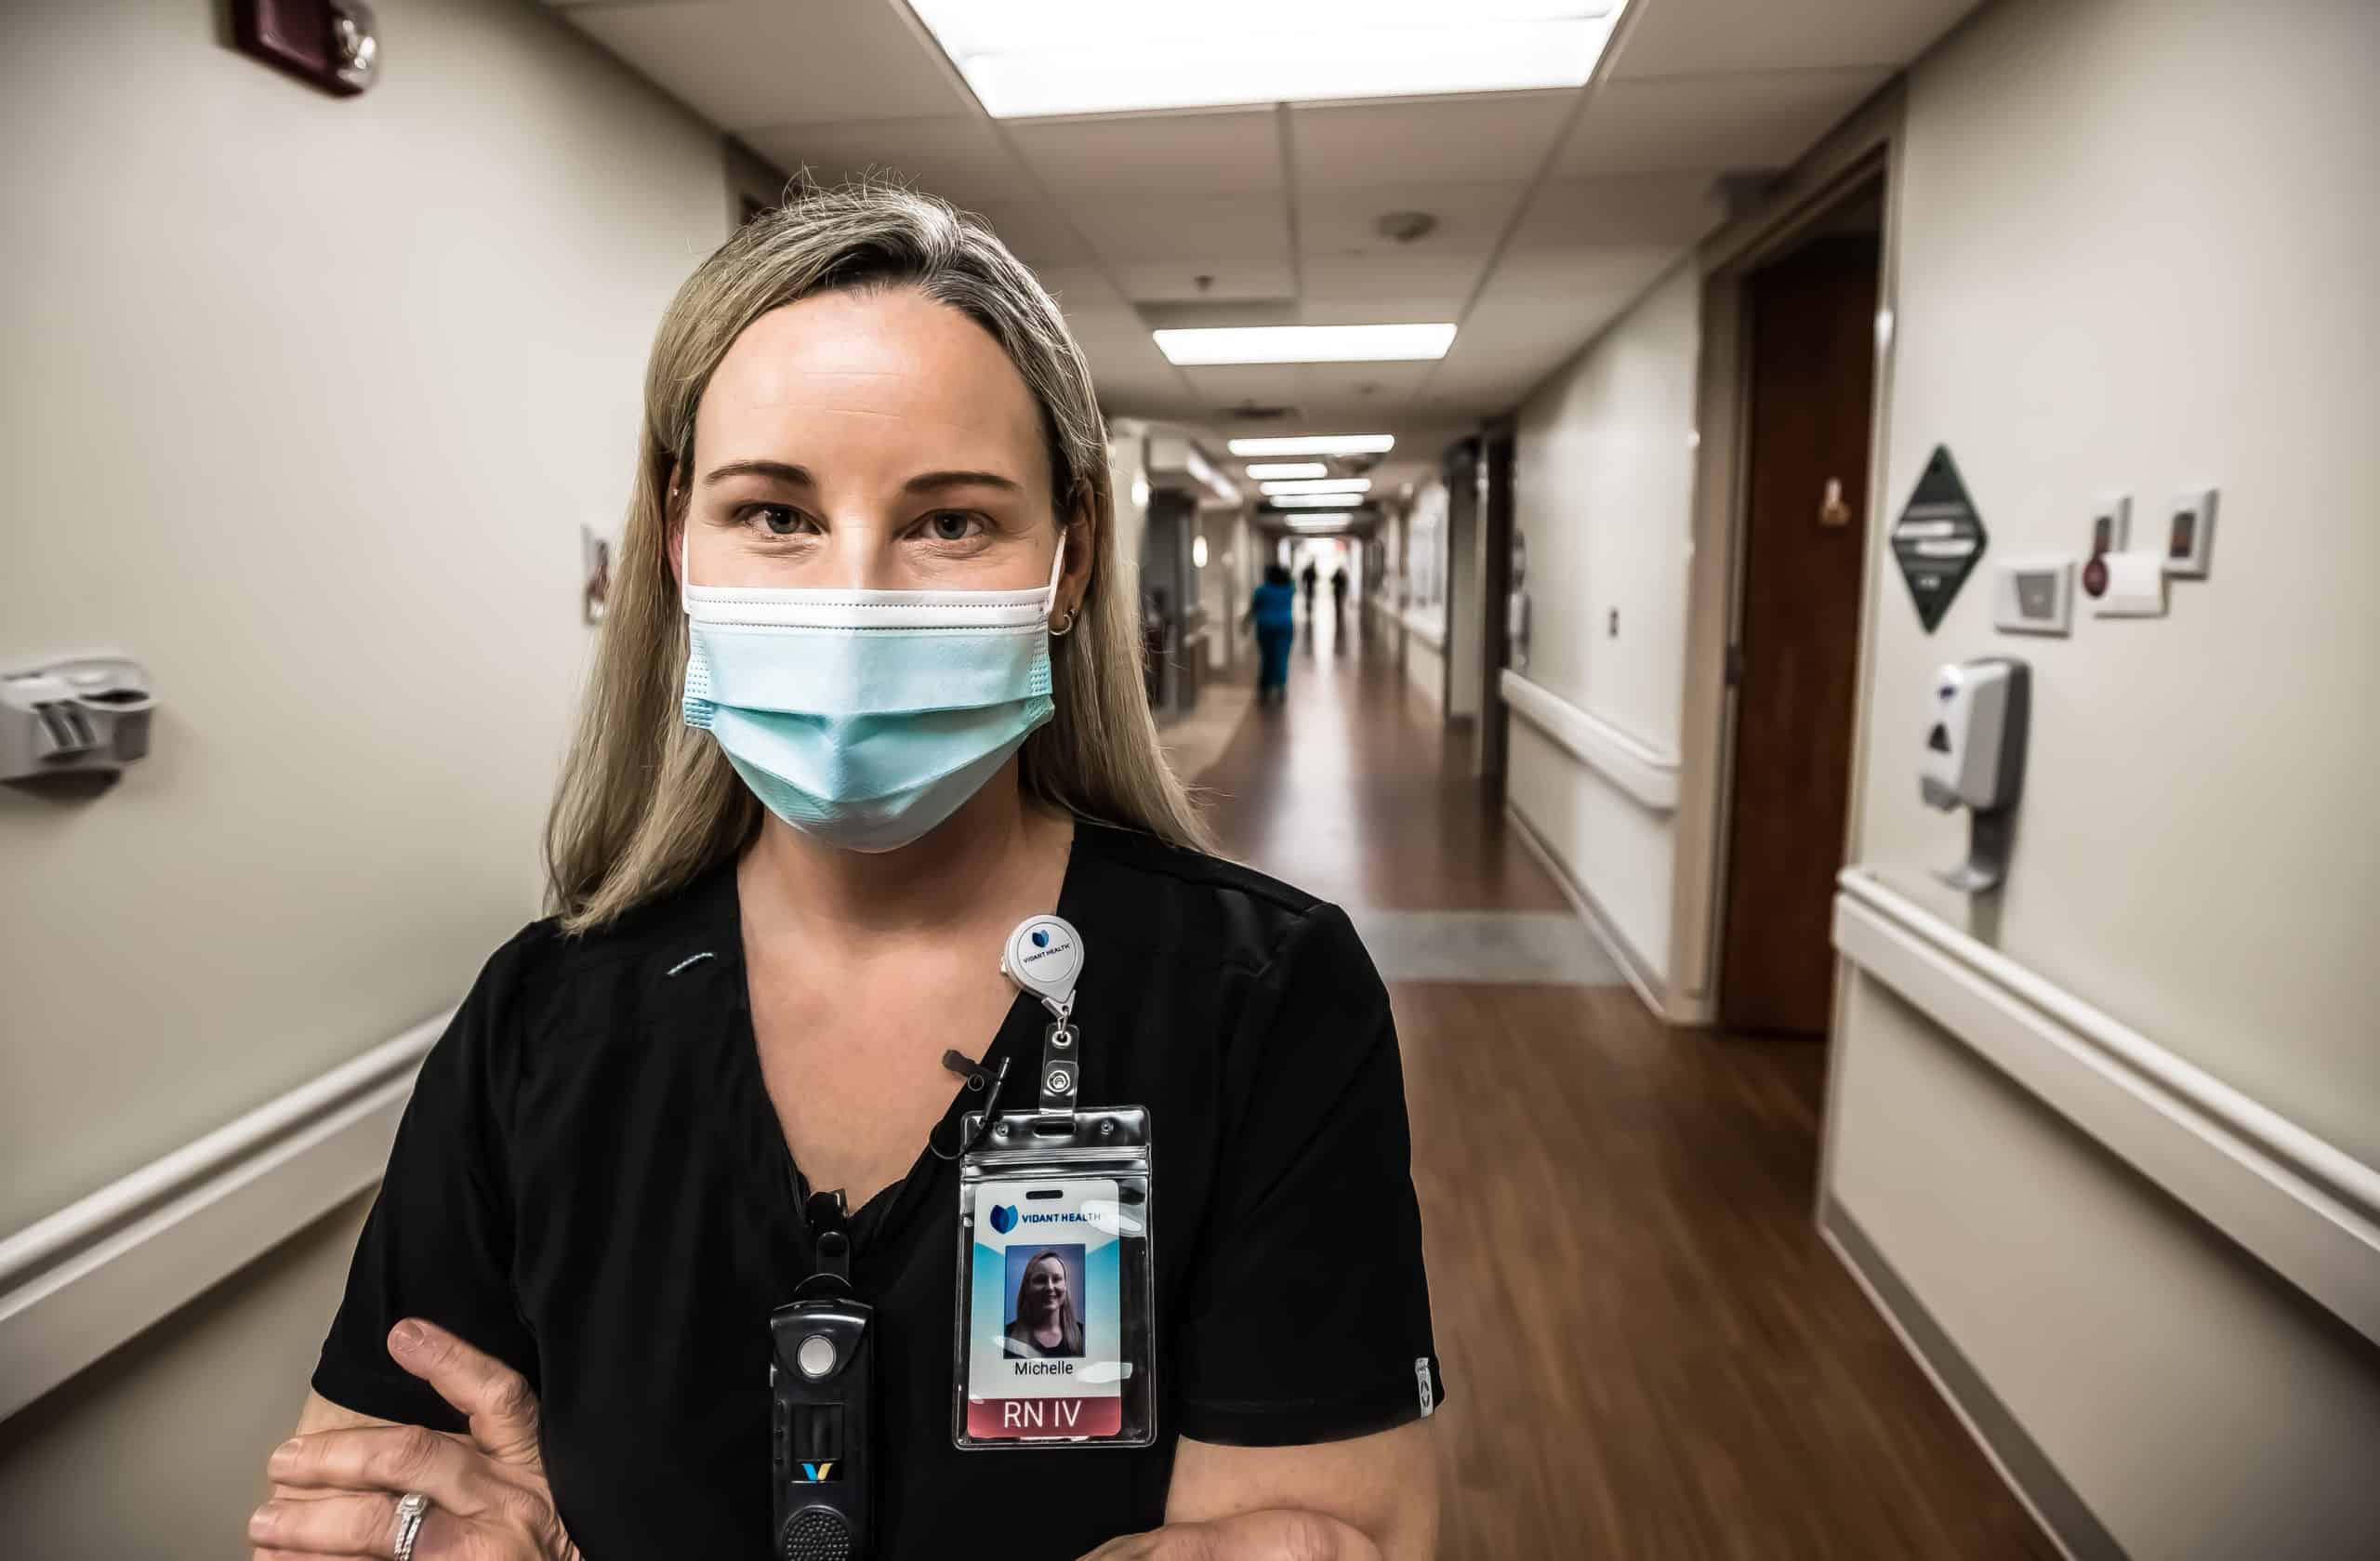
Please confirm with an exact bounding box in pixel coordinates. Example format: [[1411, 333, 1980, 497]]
[[250, 188, 1442, 1561]]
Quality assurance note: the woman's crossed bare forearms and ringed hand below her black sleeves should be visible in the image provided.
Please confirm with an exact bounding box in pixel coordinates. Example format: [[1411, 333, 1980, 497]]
[[247, 1320, 1437, 1561]]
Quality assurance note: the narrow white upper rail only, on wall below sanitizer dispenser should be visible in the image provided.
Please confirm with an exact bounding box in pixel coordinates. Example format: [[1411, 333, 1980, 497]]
[[1837, 866, 2380, 1225]]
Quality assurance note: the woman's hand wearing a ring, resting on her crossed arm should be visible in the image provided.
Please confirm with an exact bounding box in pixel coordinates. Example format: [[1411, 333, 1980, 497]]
[[247, 1318, 581, 1561]]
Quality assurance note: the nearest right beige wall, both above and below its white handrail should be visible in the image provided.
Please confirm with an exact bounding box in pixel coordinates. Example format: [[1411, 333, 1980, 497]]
[[1831, 0, 2380, 1558]]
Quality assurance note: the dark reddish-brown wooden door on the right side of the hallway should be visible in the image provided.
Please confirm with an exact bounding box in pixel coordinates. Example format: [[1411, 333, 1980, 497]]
[[1718, 233, 1878, 1033]]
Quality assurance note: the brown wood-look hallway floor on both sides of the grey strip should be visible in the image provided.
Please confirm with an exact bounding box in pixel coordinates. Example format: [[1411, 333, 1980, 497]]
[[1204, 630, 2056, 1561]]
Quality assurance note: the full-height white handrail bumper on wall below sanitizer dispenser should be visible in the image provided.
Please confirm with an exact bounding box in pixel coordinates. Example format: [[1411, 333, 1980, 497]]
[[1835, 866, 2380, 1343]]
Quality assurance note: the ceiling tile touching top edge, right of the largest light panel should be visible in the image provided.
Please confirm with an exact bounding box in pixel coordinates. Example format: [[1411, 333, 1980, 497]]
[[1611, 0, 1976, 81]]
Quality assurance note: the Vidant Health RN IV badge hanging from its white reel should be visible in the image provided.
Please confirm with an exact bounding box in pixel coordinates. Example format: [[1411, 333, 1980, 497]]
[[952, 916, 1157, 1449]]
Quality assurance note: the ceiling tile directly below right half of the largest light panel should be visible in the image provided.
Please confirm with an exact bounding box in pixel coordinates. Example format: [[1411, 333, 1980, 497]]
[[1290, 93, 1578, 191]]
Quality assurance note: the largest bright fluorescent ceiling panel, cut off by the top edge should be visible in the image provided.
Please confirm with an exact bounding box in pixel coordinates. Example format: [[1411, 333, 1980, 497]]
[[909, 0, 1623, 119]]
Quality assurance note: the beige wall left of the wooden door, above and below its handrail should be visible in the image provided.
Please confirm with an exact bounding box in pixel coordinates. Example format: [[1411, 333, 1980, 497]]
[[1506, 264, 1701, 978]]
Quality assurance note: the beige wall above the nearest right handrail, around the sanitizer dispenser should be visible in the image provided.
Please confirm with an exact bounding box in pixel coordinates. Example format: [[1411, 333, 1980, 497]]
[[1857, 0, 2380, 1161]]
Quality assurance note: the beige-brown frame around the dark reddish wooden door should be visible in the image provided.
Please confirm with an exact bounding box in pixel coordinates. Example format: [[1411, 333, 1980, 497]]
[[1666, 81, 1904, 1025]]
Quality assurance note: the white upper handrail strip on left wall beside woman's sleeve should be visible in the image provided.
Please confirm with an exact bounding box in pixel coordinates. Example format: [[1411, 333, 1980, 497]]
[[0, 1009, 452, 1292]]
